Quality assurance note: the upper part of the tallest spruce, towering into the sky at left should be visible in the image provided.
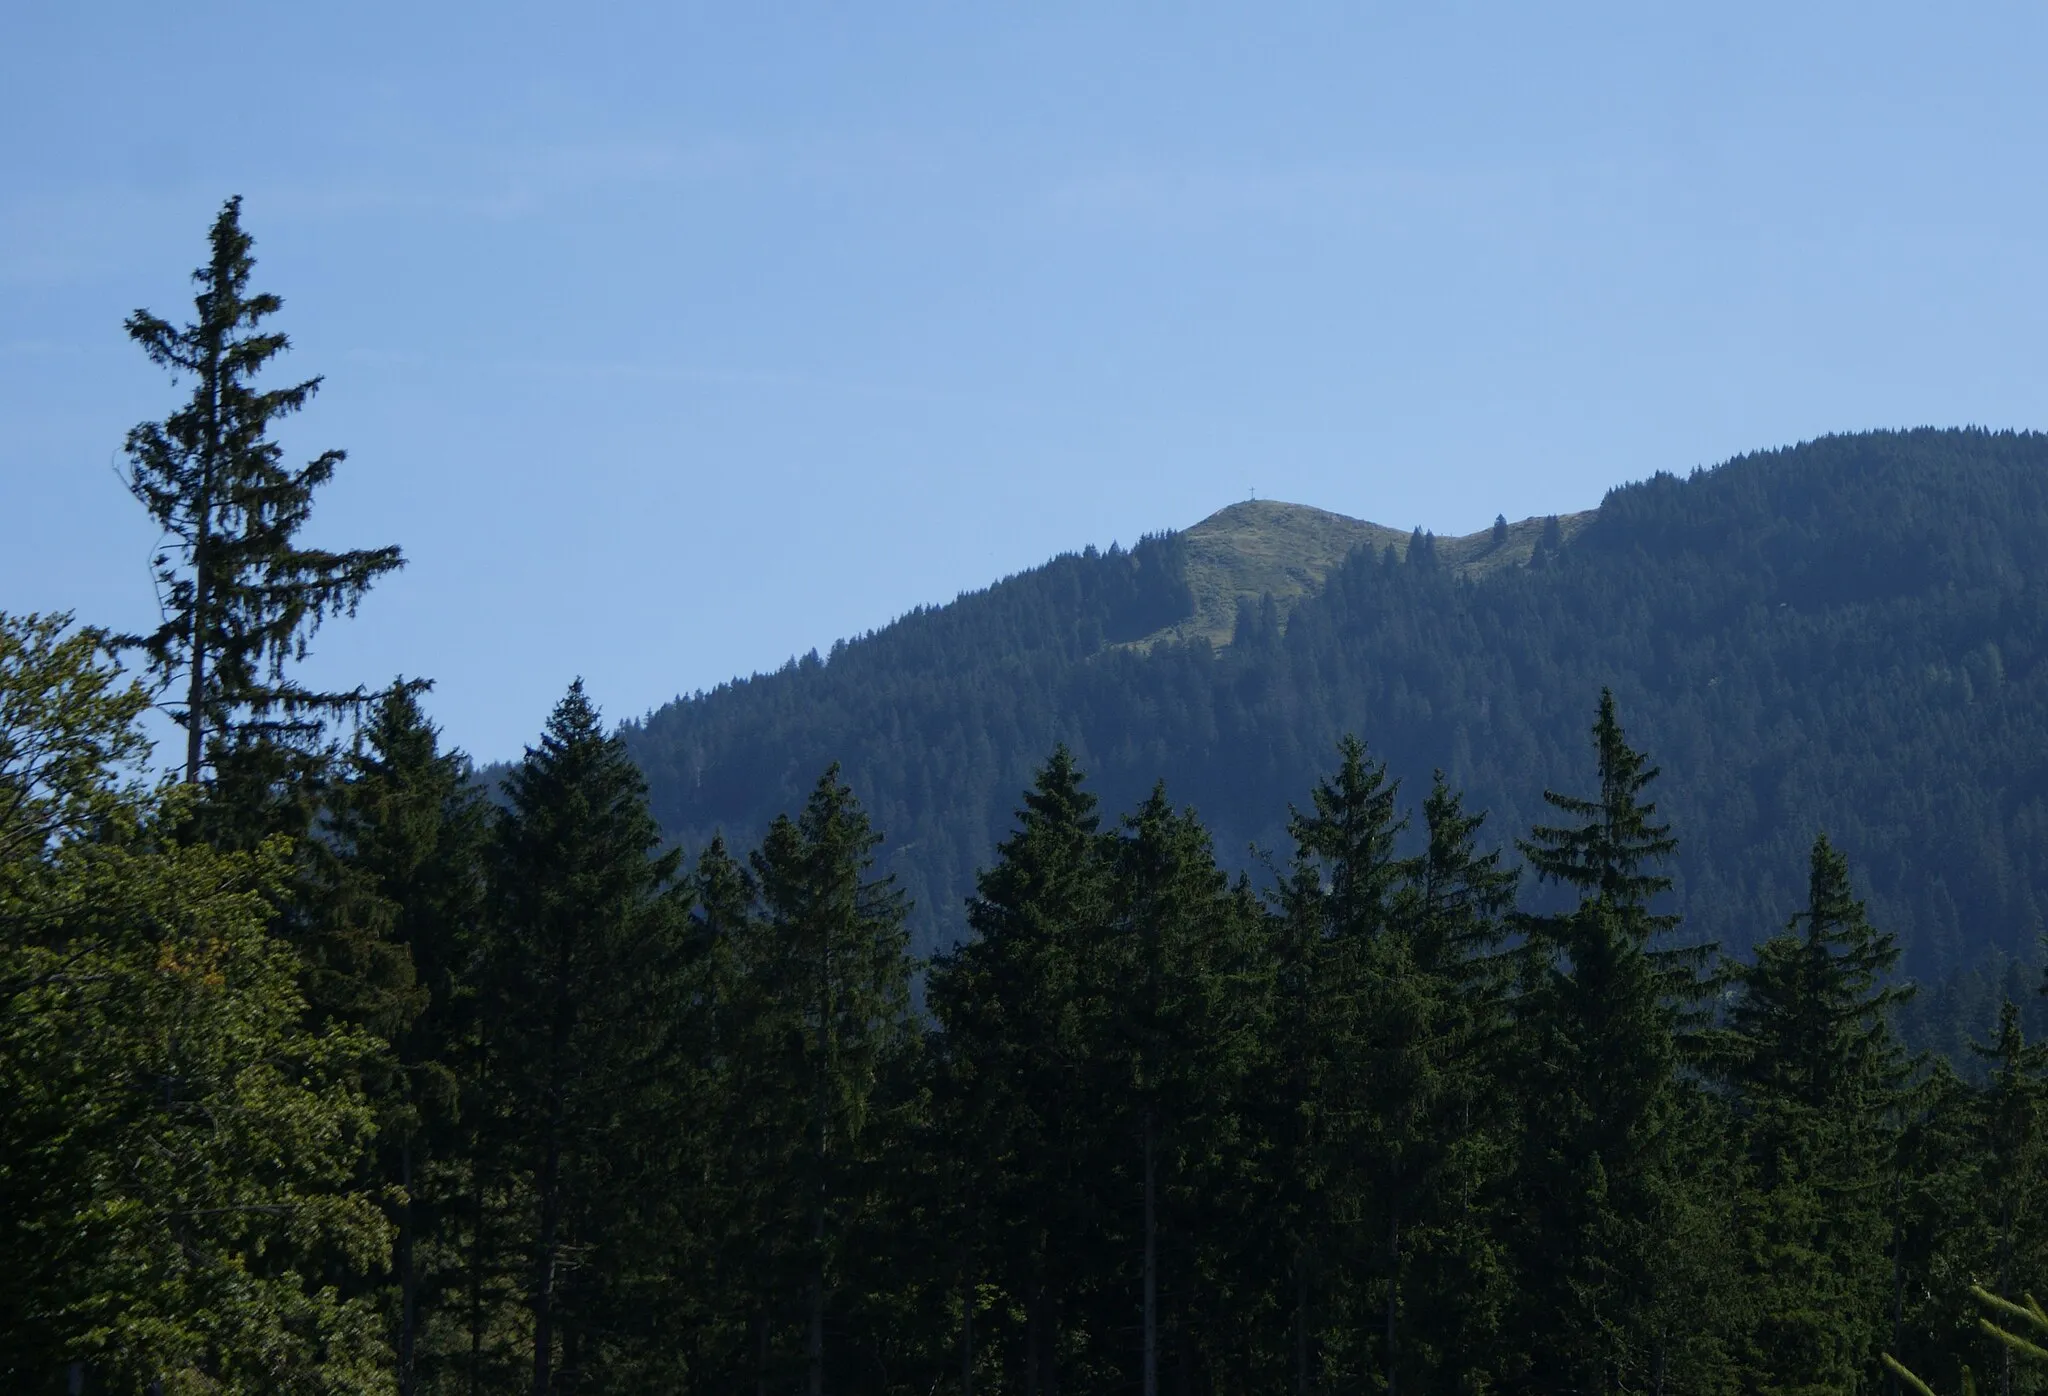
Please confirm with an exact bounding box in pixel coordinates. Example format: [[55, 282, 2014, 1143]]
[[127, 197, 401, 784]]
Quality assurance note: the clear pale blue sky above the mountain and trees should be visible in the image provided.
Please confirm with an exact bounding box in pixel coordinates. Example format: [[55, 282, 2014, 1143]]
[[0, 0, 2048, 757]]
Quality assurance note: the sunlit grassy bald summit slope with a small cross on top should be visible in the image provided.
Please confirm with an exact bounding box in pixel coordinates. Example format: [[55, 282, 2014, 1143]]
[[1163, 499, 1593, 647]]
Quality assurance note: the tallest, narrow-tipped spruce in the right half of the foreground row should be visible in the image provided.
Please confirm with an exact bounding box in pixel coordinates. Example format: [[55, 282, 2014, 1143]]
[[1516, 692, 1712, 1390]]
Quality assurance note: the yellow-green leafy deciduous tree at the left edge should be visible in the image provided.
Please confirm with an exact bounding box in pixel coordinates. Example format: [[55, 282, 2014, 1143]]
[[0, 614, 389, 1396]]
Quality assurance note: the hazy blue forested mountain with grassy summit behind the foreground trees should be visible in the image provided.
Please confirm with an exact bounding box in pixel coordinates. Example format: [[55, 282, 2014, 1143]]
[[625, 430, 2048, 974]]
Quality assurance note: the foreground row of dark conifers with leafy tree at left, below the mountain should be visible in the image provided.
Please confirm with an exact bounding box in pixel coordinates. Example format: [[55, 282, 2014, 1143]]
[[16, 620, 2048, 1394]]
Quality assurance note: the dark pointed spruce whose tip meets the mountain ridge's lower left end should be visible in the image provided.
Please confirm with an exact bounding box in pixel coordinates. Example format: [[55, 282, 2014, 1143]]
[[481, 682, 688, 1396]]
